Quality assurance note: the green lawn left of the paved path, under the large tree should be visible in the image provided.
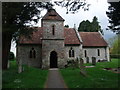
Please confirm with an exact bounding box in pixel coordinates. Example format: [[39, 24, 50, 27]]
[[2, 61, 48, 88]]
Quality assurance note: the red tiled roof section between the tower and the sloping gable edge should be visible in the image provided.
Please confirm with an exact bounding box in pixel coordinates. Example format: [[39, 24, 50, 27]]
[[64, 28, 80, 44]]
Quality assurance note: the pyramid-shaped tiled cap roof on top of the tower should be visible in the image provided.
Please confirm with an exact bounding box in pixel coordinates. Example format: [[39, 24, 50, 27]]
[[42, 9, 64, 21]]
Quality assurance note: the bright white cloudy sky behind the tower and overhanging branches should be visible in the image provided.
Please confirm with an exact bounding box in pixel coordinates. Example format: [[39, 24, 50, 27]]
[[37, 0, 109, 28]]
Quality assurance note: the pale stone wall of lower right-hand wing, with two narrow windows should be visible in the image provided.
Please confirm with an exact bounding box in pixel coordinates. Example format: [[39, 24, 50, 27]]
[[83, 47, 109, 63]]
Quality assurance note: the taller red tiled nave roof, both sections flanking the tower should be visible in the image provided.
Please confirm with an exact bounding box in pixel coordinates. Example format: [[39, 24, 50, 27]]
[[19, 27, 80, 44]]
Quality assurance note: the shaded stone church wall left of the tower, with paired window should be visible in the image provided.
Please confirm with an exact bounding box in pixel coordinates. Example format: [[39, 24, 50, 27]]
[[17, 45, 42, 67]]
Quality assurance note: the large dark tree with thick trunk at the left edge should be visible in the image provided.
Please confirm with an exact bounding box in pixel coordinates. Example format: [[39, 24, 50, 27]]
[[2, 2, 53, 69]]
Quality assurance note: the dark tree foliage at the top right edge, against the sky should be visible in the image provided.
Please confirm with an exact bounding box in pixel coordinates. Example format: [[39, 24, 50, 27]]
[[106, 2, 120, 33]]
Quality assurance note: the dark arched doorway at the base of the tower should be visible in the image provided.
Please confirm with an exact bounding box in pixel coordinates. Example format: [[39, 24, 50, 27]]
[[50, 51, 58, 68]]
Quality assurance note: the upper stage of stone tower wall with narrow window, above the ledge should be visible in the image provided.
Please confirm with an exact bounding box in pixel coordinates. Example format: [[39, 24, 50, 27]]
[[42, 20, 64, 39]]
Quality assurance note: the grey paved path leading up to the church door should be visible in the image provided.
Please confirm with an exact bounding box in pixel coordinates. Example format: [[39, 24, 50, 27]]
[[45, 68, 67, 88]]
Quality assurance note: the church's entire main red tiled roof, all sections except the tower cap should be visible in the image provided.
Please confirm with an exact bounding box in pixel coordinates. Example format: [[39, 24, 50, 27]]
[[19, 27, 107, 46]]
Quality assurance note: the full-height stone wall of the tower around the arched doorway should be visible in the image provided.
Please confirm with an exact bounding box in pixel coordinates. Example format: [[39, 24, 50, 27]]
[[42, 20, 66, 68]]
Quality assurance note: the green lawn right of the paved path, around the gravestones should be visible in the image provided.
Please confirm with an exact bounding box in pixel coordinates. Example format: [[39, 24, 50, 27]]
[[60, 59, 120, 88]]
